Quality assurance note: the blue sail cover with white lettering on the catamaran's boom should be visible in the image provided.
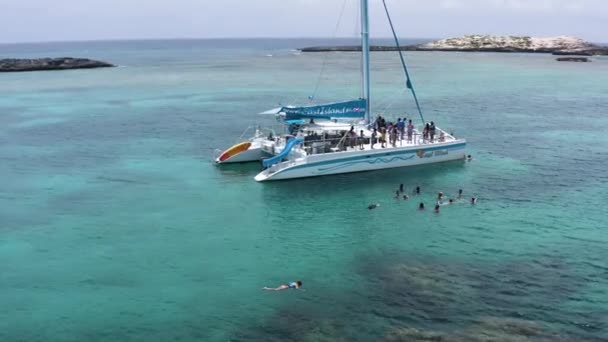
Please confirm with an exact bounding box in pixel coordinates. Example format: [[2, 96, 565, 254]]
[[281, 99, 366, 120]]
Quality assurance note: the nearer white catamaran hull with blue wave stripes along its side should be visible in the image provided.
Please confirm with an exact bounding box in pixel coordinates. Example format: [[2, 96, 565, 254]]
[[255, 140, 466, 182]]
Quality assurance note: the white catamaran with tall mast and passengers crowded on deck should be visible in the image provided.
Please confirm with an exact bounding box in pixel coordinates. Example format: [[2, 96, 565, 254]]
[[215, 0, 466, 182]]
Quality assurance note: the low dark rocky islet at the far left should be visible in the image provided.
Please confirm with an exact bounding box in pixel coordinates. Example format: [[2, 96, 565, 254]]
[[0, 57, 115, 72]]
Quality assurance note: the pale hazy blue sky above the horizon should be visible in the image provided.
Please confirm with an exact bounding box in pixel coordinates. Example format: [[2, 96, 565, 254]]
[[0, 0, 608, 43]]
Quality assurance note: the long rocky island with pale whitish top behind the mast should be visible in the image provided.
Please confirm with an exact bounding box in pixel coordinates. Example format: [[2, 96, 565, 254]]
[[300, 35, 608, 56]]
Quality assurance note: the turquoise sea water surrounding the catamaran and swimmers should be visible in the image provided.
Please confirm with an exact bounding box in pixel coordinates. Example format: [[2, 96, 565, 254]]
[[0, 40, 608, 341]]
